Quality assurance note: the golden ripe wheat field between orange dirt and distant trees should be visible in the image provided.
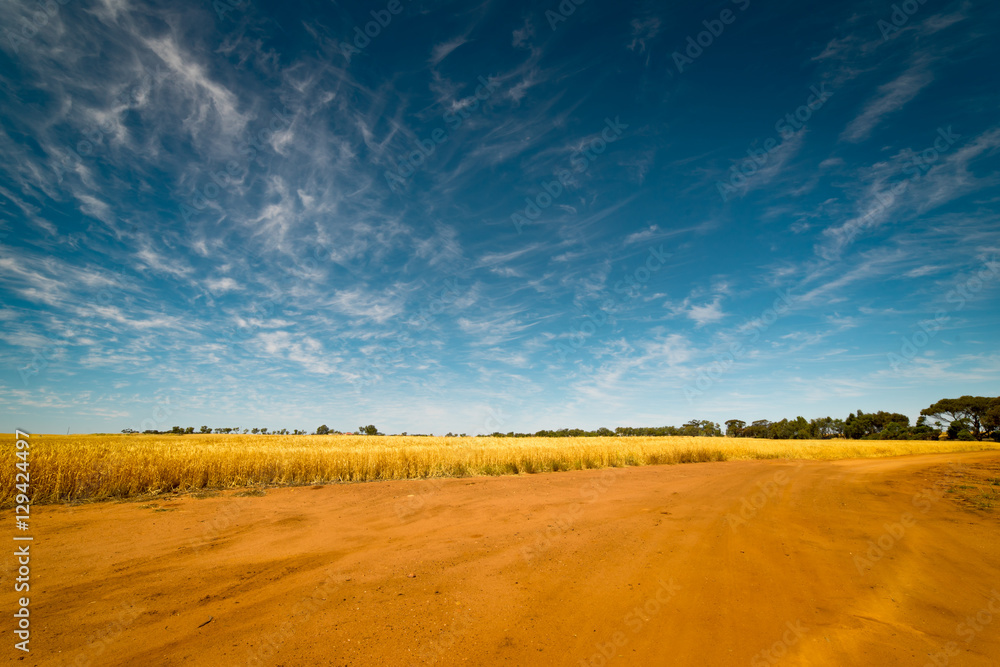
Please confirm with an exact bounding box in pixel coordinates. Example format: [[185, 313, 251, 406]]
[[0, 434, 1000, 507]]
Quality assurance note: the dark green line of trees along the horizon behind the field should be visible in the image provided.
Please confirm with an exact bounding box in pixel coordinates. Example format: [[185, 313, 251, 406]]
[[122, 396, 1000, 442]]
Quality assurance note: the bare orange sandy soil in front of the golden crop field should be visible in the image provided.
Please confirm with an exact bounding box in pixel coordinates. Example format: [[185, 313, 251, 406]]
[[0, 452, 1000, 667]]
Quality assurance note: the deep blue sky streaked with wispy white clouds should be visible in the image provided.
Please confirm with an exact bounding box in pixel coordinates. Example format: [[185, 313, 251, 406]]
[[0, 0, 1000, 434]]
